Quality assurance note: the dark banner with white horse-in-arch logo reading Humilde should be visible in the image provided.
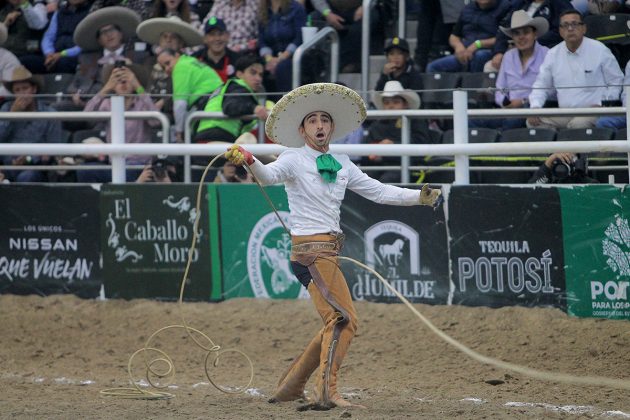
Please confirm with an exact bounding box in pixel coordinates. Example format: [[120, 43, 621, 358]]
[[341, 191, 449, 304]]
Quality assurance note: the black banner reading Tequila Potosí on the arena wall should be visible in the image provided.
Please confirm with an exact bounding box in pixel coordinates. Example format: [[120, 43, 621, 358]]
[[448, 186, 566, 308]]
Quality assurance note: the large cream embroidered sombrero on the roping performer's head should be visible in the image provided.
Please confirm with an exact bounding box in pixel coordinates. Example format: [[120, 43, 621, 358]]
[[265, 83, 366, 147]]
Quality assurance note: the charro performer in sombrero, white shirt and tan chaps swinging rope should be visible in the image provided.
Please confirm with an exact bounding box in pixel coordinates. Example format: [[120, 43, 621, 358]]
[[225, 83, 441, 409]]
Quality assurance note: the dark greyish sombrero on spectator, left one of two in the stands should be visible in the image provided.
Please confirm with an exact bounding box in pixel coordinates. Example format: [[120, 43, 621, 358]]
[[73, 6, 141, 51]]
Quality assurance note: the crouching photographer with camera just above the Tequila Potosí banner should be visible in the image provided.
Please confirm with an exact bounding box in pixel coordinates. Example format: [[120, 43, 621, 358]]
[[529, 152, 599, 184]]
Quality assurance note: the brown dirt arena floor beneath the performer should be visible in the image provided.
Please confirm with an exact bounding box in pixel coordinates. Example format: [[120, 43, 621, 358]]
[[0, 295, 630, 419]]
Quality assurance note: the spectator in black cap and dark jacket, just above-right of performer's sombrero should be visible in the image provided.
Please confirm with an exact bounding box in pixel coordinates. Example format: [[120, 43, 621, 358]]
[[374, 36, 422, 91]]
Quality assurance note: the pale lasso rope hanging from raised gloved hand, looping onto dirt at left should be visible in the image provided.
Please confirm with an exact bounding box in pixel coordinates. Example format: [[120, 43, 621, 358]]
[[101, 154, 254, 400]]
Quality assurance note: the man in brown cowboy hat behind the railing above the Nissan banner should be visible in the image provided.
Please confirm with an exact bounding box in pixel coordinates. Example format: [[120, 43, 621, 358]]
[[0, 66, 61, 182]]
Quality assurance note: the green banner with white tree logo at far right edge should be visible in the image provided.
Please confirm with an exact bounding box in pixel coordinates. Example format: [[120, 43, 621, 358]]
[[559, 185, 630, 319]]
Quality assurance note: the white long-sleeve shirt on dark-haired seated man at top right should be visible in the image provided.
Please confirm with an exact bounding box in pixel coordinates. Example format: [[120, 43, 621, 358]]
[[529, 37, 623, 108]]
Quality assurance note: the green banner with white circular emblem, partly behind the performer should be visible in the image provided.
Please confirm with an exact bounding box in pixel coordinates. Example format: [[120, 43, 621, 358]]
[[217, 184, 308, 299]]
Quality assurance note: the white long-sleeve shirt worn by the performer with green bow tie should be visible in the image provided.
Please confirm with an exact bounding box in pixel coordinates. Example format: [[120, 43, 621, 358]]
[[251, 146, 420, 235]]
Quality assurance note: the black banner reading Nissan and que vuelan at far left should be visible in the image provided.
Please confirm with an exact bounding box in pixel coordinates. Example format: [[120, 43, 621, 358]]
[[0, 185, 102, 298]]
